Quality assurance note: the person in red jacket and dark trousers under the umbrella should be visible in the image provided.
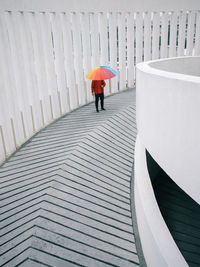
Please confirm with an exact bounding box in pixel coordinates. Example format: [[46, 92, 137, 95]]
[[91, 80, 106, 112]]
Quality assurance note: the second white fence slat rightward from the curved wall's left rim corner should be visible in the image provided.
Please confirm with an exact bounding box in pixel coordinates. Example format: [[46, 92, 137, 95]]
[[144, 12, 151, 61]]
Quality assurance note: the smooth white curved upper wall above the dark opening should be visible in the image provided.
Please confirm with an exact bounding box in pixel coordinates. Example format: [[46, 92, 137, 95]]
[[136, 57, 200, 203]]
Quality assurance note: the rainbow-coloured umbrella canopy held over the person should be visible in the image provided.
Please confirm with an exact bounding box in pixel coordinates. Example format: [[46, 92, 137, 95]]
[[86, 66, 117, 80]]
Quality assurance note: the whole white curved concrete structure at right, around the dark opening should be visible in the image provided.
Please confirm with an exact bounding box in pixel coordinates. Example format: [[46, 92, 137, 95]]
[[135, 57, 200, 267]]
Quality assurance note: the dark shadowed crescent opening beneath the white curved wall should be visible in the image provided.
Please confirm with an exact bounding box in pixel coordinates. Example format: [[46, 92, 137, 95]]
[[146, 150, 200, 267]]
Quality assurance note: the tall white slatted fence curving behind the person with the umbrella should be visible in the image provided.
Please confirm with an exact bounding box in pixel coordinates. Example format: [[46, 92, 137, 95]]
[[0, 8, 200, 162]]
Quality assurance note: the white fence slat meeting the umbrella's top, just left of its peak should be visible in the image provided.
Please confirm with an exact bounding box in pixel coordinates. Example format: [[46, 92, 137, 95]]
[[90, 13, 100, 68]]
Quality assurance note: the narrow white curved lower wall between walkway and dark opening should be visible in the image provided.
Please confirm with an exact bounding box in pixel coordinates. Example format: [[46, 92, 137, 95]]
[[134, 135, 188, 267]]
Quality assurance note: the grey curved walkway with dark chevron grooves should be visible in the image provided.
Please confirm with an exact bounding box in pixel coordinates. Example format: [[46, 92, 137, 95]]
[[0, 90, 139, 267]]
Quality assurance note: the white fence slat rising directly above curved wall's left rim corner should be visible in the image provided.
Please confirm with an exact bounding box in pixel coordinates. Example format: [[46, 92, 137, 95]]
[[136, 12, 143, 64]]
